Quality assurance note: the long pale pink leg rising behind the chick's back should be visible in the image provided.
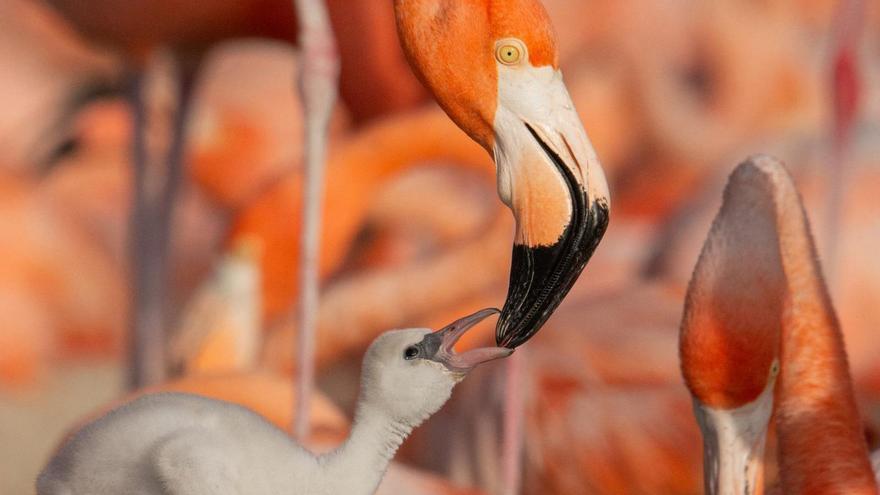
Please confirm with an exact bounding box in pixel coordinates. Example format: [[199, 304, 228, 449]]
[[294, 0, 339, 441]]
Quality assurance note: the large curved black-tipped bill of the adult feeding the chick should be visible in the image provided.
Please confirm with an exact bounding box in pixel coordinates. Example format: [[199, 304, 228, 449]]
[[494, 67, 610, 348]]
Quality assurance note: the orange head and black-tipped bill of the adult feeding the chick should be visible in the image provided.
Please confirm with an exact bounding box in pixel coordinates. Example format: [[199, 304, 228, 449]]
[[394, 0, 609, 348]]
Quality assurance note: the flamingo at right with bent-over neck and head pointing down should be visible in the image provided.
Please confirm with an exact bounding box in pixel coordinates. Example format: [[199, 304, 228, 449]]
[[680, 156, 878, 494]]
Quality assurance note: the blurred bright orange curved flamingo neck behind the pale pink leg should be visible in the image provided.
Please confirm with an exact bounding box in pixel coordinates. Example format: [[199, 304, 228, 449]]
[[230, 109, 491, 324]]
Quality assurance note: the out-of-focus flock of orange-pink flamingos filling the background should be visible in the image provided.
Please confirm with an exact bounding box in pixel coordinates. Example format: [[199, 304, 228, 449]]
[[0, 0, 880, 495]]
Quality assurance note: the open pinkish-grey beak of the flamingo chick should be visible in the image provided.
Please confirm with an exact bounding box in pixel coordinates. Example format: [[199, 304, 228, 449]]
[[423, 308, 513, 373]]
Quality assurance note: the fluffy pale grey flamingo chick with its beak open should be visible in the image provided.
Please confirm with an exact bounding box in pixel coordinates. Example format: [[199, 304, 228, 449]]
[[37, 309, 513, 495]]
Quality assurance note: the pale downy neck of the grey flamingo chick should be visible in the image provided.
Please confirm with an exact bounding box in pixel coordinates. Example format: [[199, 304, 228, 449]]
[[322, 401, 416, 495]]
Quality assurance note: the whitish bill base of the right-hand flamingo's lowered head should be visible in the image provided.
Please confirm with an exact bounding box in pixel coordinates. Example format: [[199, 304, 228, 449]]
[[694, 362, 779, 495]]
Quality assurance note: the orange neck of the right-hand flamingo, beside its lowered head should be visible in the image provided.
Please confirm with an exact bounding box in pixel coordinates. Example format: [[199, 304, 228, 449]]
[[777, 203, 877, 494]]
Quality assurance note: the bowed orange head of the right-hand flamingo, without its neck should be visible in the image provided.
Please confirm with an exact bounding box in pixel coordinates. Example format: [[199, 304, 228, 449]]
[[679, 158, 787, 494]]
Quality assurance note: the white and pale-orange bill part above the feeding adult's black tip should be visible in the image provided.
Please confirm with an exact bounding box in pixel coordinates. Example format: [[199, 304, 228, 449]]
[[494, 55, 610, 245]]
